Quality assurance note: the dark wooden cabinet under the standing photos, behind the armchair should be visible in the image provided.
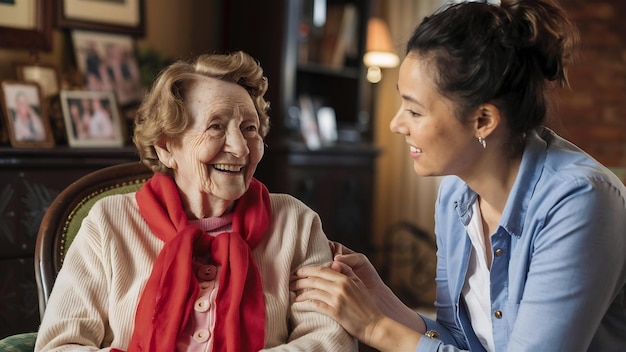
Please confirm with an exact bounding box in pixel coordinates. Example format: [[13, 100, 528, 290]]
[[0, 147, 139, 338]]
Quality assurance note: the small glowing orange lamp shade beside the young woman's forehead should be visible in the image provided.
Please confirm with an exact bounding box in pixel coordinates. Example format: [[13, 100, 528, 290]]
[[363, 17, 400, 68]]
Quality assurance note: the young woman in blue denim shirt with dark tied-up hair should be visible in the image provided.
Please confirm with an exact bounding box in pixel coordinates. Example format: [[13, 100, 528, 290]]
[[292, 0, 626, 351]]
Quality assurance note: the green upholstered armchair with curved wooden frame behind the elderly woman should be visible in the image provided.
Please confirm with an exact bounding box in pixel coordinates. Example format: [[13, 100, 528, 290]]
[[0, 162, 152, 352]]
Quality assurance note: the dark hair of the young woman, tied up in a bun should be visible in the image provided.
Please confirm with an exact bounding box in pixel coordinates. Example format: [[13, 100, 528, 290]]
[[406, 0, 578, 154]]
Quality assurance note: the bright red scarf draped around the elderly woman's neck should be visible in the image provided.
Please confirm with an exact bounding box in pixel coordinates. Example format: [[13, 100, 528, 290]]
[[113, 174, 272, 352]]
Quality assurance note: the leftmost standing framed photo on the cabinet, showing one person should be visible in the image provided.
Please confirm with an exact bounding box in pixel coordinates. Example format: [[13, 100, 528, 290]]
[[0, 81, 54, 148]]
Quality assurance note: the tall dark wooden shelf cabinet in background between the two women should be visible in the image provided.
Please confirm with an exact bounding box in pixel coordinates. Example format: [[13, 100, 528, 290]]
[[222, 0, 378, 253]]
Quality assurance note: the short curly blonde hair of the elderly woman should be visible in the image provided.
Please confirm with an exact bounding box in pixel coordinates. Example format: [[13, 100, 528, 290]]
[[133, 51, 270, 174]]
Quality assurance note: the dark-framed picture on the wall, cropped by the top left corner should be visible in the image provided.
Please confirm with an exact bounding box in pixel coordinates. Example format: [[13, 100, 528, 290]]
[[0, 0, 53, 51]]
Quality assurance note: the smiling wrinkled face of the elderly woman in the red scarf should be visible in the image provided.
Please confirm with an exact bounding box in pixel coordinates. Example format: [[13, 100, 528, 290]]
[[161, 77, 264, 212]]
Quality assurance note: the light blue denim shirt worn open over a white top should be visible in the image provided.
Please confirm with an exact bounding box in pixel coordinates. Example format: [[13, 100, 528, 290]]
[[417, 128, 626, 352]]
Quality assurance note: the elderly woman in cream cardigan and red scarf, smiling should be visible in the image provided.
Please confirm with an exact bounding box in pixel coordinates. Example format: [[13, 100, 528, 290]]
[[36, 52, 356, 351]]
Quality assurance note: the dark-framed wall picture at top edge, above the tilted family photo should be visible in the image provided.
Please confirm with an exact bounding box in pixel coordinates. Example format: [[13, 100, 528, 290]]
[[57, 0, 144, 36]]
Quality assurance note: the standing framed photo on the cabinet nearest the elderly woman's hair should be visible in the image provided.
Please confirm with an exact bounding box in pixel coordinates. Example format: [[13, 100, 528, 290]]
[[60, 90, 124, 147]]
